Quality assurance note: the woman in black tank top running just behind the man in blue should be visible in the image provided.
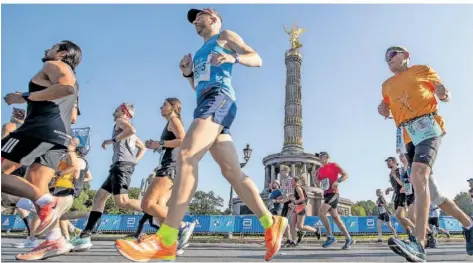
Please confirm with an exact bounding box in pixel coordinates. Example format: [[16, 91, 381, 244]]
[[128, 98, 189, 241]]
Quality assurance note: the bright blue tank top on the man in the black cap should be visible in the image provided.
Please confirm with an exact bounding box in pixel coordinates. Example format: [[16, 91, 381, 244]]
[[193, 34, 236, 100]]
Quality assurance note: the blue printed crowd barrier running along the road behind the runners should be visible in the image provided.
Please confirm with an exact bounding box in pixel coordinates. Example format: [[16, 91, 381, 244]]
[[2, 215, 462, 235]]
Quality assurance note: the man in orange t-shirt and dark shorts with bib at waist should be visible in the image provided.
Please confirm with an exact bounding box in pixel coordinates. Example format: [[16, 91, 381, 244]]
[[378, 46, 473, 262]]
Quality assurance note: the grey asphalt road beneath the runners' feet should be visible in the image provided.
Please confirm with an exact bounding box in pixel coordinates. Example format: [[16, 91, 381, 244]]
[[1, 238, 473, 262]]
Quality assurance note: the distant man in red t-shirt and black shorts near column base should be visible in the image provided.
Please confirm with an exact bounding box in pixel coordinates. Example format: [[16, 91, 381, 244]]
[[314, 152, 356, 249]]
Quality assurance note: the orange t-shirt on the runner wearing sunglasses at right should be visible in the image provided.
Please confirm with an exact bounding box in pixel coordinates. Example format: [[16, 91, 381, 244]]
[[383, 65, 445, 144]]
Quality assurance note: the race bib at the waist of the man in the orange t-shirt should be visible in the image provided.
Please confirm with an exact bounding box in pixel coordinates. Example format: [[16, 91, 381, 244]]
[[405, 115, 443, 145]]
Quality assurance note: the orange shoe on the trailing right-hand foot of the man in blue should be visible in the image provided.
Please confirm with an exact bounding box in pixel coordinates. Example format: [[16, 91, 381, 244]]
[[264, 216, 287, 261]]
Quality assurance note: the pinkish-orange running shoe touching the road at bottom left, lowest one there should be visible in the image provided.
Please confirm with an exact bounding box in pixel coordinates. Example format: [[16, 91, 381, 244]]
[[16, 237, 72, 261]]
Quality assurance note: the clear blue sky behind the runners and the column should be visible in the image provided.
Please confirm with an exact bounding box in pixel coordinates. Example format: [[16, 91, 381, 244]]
[[1, 4, 473, 208]]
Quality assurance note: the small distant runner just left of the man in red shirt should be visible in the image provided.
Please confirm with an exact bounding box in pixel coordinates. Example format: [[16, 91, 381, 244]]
[[289, 177, 320, 243]]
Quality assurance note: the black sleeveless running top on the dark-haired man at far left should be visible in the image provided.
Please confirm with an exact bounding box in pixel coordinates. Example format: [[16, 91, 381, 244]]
[[14, 81, 79, 147]]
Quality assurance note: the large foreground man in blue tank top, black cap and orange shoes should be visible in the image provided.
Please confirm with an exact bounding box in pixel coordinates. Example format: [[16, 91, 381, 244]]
[[117, 9, 287, 261]]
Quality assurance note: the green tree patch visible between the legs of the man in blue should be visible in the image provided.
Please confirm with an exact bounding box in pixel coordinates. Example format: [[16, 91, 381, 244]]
[[189, 191, 223, 215]]
